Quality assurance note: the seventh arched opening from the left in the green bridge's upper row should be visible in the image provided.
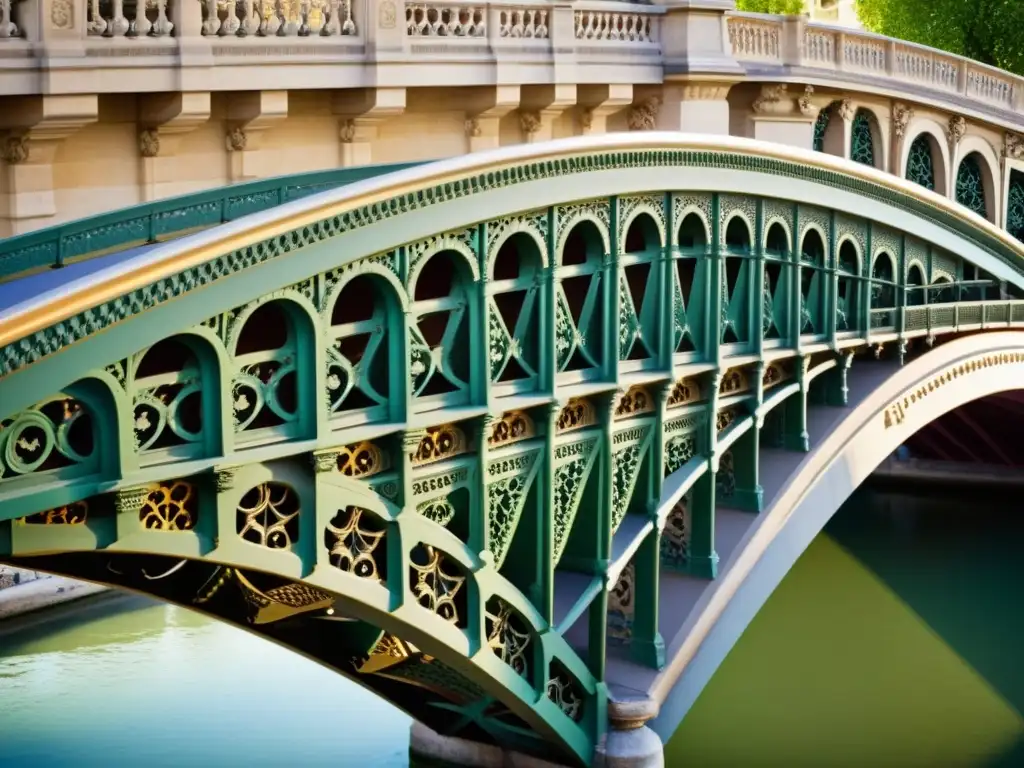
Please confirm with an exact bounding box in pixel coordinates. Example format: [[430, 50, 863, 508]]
[[555, 218, 608, 379]]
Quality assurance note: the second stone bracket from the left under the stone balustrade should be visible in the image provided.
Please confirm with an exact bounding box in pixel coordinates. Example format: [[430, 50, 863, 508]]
[[138, 91, 210, 201]]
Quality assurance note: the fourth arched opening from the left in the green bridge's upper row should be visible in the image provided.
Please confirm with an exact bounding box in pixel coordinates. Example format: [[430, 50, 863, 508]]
[[324, 265, 406, 429]]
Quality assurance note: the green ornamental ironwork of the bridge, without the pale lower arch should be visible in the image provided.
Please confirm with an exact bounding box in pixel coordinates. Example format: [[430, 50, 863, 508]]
[[0, 141, 1024, 763]]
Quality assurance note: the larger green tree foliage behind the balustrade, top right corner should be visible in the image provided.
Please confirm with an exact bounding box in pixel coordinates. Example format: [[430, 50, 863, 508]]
[[856, 0, 1024, 75]]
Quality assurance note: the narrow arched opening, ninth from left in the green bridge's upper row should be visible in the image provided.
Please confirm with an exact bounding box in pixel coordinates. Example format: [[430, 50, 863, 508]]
[[673, 210, 711, 353]]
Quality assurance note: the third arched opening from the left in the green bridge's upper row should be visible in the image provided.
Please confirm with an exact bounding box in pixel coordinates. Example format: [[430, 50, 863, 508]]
[[227, 295, 319, 445]]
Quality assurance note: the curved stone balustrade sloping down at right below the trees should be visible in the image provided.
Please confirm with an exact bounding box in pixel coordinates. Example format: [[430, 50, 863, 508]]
[[729, 13, 1024, 112]]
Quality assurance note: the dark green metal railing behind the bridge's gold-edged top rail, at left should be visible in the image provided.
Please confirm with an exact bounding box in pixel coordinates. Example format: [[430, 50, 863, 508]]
[[0, 163, 422, 280]]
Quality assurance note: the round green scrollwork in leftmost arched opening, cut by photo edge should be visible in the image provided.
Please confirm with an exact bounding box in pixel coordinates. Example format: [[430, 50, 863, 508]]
[[0, 396, 98, 482]]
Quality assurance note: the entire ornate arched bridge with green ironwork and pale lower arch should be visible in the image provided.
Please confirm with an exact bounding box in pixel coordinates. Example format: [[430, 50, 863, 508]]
[[6, 123, 1024, 765]]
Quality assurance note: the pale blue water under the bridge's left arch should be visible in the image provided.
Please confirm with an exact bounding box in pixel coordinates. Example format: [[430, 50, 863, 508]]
[[0, 595, 410, 768]]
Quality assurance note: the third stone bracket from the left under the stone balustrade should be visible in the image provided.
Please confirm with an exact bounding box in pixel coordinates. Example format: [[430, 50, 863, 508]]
[[224, 91, 288, 183]]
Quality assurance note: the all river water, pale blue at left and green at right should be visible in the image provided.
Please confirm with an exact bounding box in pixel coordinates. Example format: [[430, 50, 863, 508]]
[[0, 489, 1024, 768]]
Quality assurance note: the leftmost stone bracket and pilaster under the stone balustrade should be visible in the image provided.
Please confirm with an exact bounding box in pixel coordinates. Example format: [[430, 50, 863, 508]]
[[0, 94, 99, 237]]
